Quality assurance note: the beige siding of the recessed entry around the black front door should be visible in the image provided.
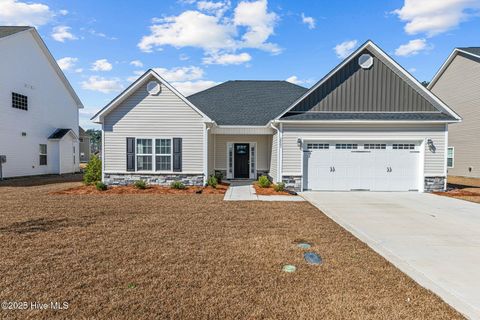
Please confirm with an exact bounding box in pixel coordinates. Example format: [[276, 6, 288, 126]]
[[214, 134, 272, 171]]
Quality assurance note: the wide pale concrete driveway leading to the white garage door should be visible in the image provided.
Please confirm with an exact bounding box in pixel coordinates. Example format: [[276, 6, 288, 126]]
[[302, 192, 480, 319]]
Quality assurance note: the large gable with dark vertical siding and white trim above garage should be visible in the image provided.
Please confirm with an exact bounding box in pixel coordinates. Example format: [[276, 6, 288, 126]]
[[275, 40, 461, 122]]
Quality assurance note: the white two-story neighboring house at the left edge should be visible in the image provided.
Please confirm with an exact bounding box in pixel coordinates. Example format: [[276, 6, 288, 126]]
[[0, 27, 83, 177]]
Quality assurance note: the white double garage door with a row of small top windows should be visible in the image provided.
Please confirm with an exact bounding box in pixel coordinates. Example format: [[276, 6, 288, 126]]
[[304, 141, 420, 191]]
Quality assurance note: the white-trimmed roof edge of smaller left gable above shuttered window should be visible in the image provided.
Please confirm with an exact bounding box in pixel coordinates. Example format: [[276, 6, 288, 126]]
[[90, 69, 212, 123]]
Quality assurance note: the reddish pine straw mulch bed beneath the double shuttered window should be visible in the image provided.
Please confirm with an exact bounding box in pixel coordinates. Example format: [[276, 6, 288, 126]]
[[52, 184, 228, 195]]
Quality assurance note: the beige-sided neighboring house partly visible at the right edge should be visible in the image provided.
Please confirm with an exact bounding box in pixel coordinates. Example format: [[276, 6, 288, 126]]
[[428, 47, 480, 178]]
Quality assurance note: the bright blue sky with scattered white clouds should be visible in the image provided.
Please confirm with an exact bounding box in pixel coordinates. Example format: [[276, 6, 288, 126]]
[[0, 0, 480, 128]]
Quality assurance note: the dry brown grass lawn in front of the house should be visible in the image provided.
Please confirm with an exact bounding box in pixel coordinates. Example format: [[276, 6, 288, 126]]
[[0, 176, 462, 319]]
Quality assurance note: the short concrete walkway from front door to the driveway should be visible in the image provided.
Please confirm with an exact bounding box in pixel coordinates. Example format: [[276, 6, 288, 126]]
[[223, 181, 305, 201]]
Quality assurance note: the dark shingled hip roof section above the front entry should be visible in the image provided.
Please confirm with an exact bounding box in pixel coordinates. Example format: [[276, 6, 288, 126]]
[[188, 80, 307, 126]]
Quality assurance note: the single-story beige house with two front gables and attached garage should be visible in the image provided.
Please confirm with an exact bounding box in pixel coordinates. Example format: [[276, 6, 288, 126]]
[[92, 41, 460, 191]]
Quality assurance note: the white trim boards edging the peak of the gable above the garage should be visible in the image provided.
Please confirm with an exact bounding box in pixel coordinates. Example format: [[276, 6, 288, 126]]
[[274, 40, 461, 120]]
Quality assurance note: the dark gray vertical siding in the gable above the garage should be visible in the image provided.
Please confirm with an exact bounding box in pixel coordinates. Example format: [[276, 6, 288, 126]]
[[291, 50, 438, 113]]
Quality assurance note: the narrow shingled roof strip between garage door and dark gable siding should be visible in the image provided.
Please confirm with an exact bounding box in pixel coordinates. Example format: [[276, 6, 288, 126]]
[[282, 112, 455, 121]]
